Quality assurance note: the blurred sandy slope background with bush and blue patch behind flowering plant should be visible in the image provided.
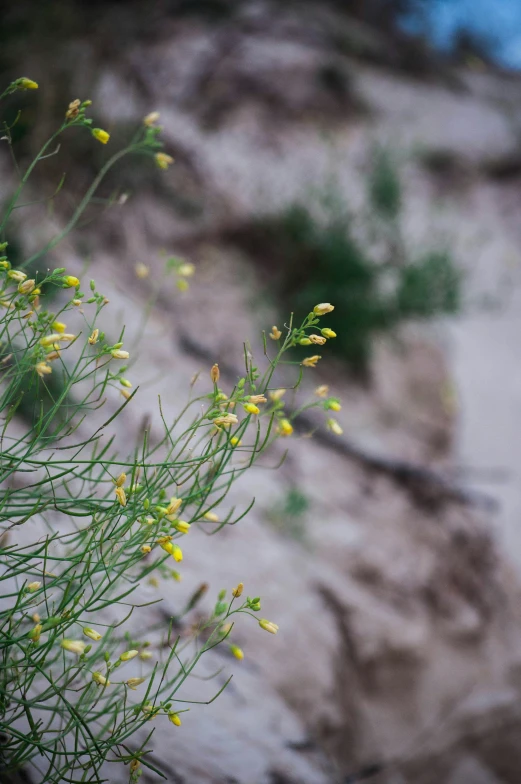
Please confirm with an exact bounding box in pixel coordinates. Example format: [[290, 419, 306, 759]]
[[5, 0, 521, 784]]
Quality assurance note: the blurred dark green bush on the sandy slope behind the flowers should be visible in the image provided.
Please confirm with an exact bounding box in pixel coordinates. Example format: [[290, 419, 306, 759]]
[[228, 150, 461, 378]]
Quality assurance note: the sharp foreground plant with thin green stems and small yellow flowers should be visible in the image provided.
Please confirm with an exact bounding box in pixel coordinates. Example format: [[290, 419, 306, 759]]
[[0, 79, 341, 784]]
